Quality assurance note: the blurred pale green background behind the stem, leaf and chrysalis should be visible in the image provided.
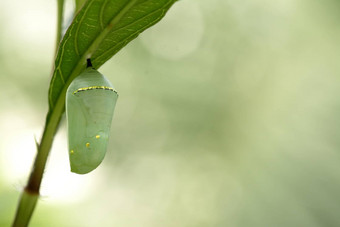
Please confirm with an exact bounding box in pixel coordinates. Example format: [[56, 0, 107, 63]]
[[0, 0, 340, 227]]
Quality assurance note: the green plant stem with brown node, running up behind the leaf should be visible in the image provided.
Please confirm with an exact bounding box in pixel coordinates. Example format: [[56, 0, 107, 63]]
[[12, 0, 65, 227]]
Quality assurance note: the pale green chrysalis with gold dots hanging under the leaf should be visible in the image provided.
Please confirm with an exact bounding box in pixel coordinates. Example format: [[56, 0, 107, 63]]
[[66, 59, 118, 174]]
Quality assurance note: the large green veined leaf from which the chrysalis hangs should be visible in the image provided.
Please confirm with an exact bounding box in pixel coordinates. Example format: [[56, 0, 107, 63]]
[[47, 0, 176, 113]]
